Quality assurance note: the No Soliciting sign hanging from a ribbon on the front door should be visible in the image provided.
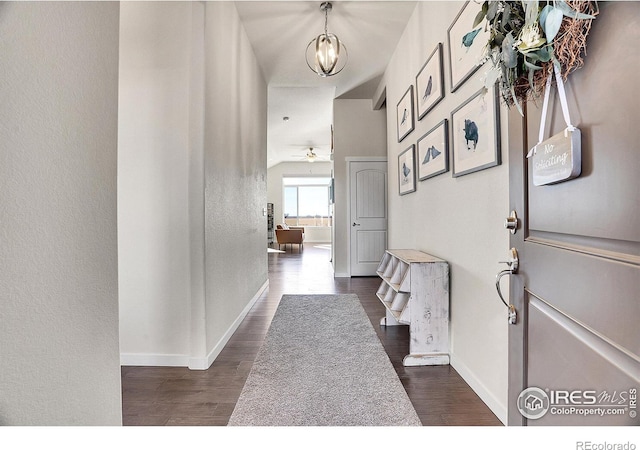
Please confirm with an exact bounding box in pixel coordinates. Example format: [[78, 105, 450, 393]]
[[531, 128, 582, 186]]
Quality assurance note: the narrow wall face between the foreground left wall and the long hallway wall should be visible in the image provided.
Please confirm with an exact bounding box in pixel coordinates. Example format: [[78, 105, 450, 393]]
[[118, 2, 192, 365]]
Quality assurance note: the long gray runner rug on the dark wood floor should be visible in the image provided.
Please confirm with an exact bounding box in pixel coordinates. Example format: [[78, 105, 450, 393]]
[[229, 294, 421, 426]]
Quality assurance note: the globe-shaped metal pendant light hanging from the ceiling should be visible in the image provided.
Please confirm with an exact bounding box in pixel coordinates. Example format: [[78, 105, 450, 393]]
[[305, 2, 347, 78]]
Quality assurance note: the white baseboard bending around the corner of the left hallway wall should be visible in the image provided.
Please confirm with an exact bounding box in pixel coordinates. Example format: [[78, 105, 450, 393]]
[[120, 280, 269, 370]]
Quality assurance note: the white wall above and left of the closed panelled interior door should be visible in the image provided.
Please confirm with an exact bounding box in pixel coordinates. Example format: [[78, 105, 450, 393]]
[[333, 99, 387, 277]]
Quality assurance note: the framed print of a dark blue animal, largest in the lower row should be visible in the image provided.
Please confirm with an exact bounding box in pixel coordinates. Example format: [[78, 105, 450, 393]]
[[451, 87, 501, 177]]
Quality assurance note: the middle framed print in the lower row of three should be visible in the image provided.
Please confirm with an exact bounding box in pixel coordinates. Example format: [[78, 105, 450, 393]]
[[416, 119, 449, 181]]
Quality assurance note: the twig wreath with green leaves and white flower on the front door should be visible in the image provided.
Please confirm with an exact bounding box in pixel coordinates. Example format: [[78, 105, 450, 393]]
[[462, 0, 598, 113]]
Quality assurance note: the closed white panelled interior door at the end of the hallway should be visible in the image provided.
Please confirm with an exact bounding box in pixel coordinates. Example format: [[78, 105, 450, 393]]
[[349, 161, 387, 276]]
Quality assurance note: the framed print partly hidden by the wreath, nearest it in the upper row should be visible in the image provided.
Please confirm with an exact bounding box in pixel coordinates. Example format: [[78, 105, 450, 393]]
[[447, 1, 489, 92]]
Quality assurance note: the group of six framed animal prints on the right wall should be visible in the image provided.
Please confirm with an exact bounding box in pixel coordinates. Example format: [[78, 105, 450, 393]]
[[396, 2, 501, 195]]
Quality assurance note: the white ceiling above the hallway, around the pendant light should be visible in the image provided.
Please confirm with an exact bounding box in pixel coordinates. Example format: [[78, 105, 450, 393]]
[[236, 0, 416, 167]]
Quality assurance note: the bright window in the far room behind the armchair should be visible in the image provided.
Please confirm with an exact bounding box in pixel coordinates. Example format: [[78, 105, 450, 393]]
[[283, 177, 332, 227]]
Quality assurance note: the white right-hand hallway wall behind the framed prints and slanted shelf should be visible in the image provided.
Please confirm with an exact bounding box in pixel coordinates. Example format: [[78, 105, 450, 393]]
[[383, 2, 509, 421]]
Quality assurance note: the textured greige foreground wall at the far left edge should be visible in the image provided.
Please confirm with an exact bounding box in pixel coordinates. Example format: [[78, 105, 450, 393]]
[[0, 2, 122, 425]]
